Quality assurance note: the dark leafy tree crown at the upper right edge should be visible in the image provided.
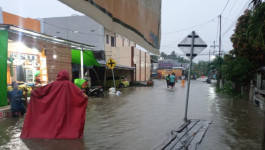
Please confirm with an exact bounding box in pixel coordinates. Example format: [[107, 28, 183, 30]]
[[230, 3, 265, 68]]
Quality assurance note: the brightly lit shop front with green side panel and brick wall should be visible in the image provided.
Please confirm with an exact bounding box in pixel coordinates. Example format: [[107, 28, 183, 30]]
[[0, 25, 93, 106]]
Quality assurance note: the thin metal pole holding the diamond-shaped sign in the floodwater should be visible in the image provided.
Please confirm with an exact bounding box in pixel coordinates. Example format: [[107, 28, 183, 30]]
[[184, 31, 195, 121]]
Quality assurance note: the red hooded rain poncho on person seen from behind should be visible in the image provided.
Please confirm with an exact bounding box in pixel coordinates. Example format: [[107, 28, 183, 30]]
[[21, 71, 87, 139]]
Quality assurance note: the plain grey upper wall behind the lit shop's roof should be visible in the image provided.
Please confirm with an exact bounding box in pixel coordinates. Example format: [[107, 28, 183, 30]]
[[42, 16, 105, 51]]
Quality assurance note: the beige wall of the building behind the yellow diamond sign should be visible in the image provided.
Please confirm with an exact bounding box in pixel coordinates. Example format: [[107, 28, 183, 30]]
[[105, 30, 151, 81]]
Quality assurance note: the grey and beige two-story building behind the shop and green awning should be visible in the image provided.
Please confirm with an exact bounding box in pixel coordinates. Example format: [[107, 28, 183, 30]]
[[41, 15, 151, 85]]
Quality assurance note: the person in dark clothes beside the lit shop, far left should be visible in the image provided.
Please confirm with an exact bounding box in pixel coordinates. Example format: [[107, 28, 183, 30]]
[[7, 81, 26, 117]]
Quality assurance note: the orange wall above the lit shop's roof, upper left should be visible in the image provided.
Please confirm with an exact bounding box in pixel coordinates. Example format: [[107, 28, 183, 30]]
[[2, 11, 40, 32]]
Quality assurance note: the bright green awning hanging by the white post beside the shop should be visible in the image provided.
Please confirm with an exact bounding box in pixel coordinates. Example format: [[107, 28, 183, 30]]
[[71, 49, 100, 67]]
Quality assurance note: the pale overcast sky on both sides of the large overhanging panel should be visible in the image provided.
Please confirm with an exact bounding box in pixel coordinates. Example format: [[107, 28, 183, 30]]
[[0, 0, 250, 61]]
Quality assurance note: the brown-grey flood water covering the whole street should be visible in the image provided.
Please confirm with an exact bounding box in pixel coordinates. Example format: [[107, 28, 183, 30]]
[[0, 80, 264, 150]]
